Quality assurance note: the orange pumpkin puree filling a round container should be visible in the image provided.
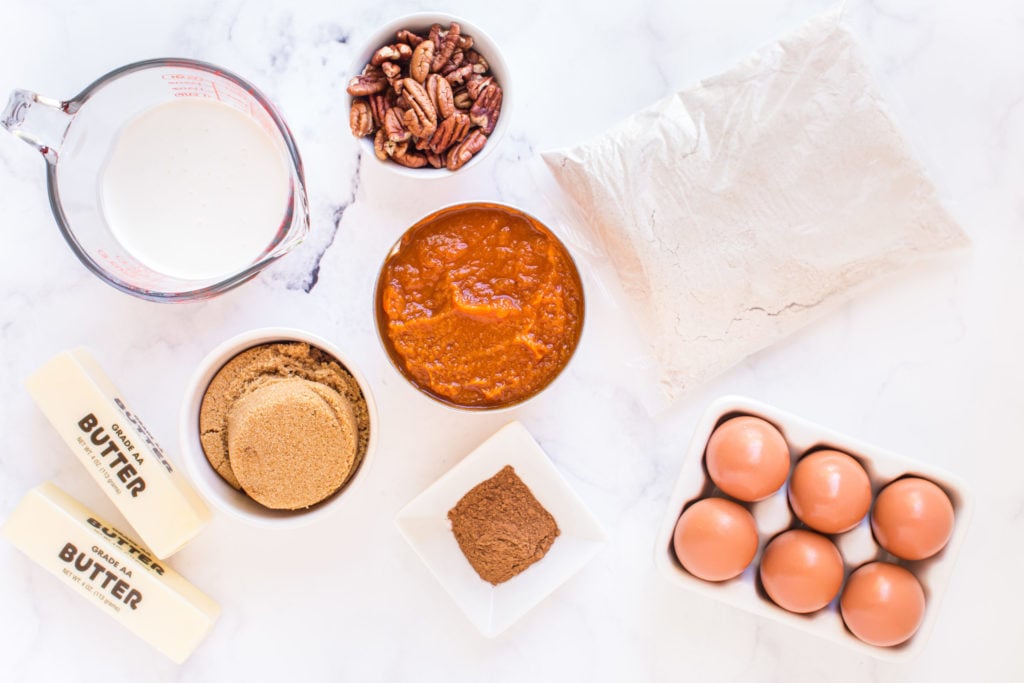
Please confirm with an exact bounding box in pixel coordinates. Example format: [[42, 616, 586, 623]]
[[377, 204, 584, 408]]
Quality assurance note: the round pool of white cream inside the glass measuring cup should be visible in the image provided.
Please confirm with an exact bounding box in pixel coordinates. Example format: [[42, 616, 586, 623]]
[[99, 99, 289, 280]]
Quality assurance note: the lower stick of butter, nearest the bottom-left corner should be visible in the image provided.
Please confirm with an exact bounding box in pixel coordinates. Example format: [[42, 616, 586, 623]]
[[0, 482, 220, 664]]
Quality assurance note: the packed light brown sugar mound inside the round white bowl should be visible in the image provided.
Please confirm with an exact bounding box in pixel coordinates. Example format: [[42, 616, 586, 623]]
[[200, 342, 370, 510]]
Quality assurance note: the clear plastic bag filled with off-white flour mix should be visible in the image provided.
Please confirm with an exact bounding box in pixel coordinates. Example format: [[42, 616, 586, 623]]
[[544, 13, 968, 396]]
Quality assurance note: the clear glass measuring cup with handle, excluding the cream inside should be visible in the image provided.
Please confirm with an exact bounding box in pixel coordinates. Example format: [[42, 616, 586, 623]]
[[0, 59, 309, 302]]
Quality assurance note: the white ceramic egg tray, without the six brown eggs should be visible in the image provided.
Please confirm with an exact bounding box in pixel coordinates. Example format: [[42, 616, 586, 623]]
[[654, 396, 974, 660]]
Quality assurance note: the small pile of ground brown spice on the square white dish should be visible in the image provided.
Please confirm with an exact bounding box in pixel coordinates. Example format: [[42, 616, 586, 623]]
[[447, 465, 559, 586]]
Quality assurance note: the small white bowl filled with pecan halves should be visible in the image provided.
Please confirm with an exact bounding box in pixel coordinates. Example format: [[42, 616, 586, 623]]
[[347, 12, 510, 178]]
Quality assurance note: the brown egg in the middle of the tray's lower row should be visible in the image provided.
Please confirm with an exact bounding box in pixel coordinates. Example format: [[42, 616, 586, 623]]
[[761, 529, 843, 614]]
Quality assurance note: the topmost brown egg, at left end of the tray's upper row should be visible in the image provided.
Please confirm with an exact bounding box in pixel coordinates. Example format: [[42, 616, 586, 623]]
[[706, 416, 790, 503]]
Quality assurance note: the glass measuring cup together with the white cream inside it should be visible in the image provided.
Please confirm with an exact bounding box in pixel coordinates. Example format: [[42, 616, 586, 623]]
[[0, 59, 309, 302]]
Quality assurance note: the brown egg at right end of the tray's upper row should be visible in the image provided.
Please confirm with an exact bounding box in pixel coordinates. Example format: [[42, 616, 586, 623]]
[[871, 477, 953, 560]]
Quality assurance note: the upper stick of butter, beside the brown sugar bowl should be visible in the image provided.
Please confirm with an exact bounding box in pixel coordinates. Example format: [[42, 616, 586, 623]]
[[26, 348, 210, 559]]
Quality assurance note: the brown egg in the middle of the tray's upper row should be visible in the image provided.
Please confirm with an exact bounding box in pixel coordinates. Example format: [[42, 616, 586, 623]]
[[790, 451, 871, 533]]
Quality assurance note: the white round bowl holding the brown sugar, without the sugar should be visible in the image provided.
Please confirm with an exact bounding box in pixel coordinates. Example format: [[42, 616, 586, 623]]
[[178, 328, 380, 528]]
